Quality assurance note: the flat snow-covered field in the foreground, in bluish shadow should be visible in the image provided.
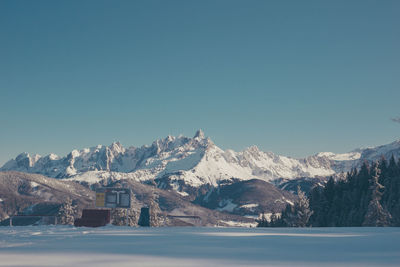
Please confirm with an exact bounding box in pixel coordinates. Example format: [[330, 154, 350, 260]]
[[0, 226, 400, 266]]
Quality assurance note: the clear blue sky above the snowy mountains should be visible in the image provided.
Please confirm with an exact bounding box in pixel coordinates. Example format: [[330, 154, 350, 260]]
[[0, 0, 400, 164]]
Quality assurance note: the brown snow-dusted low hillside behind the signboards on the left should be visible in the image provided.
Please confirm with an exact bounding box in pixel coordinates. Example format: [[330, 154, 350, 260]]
[[0, 171, 253, 226]]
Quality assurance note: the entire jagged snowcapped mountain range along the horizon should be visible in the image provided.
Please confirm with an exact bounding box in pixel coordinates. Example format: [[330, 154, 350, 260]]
[[0, 130, 400, 191]]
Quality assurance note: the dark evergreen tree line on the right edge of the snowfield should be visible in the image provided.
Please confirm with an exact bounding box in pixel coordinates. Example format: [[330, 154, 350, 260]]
[[258, 156, 400, 227]]
